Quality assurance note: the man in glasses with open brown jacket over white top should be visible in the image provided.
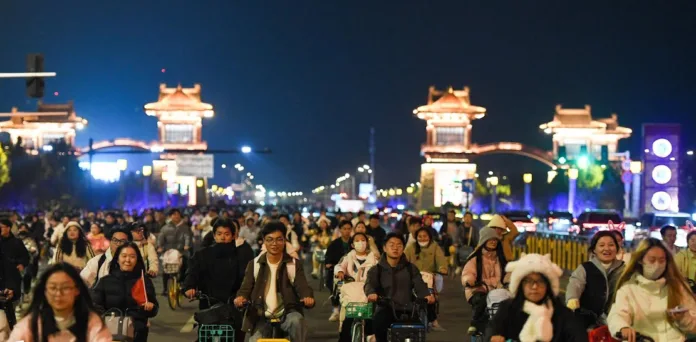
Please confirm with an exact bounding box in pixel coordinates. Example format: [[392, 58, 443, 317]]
[[234, 221, 314, 342]]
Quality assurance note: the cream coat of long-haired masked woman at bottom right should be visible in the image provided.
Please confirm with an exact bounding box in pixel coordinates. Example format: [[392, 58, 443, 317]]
[[607, 274, 696, 342]]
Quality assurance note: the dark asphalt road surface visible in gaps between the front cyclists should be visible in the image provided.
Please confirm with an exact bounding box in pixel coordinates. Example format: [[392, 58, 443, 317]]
[[149, 260, 568, 342]]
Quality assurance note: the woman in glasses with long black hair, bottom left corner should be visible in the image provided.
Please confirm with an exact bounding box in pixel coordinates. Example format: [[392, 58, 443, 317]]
[[8, 263, 111, 342]]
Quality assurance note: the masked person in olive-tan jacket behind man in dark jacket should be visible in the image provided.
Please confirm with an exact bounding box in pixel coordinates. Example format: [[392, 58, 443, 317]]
[[404, 227, 449, 331]]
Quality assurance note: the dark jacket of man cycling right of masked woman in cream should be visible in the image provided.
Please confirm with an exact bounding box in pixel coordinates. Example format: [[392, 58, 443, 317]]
[[365, 254, 430, 309]]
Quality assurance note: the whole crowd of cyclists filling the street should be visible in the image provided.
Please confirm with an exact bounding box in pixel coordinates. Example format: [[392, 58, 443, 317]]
[[0, 207, 696, 342]]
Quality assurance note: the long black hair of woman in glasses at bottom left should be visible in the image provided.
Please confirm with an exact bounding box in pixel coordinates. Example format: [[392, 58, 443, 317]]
[[28, 263, 101, 342]]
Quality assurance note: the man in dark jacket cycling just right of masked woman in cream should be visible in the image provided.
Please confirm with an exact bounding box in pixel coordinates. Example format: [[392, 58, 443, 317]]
[[364, 233, 435, 342]]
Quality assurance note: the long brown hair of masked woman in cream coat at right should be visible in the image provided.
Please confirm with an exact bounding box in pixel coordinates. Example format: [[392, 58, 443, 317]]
[[614, 238, 693, 326]]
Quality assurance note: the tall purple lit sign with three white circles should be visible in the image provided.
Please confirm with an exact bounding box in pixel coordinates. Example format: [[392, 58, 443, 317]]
[[641, 124, 681, 213]]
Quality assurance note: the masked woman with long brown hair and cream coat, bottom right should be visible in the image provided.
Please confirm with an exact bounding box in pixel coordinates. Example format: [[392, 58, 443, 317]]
[[607, 238, 696, 342]]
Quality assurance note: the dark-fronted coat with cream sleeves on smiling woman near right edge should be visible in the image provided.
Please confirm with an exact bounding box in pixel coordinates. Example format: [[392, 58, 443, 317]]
[[565, 255, 625, 327]]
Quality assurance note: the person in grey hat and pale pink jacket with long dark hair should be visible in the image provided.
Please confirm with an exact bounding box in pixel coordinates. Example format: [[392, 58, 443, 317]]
[[462, 227, 507, 335]]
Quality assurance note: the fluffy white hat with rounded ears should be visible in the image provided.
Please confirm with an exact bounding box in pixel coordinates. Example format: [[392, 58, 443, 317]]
[[505, 254, 563, 296]]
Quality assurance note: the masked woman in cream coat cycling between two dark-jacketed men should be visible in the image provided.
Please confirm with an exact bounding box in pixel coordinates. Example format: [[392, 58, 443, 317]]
[[334, 232, 379, 342]]
